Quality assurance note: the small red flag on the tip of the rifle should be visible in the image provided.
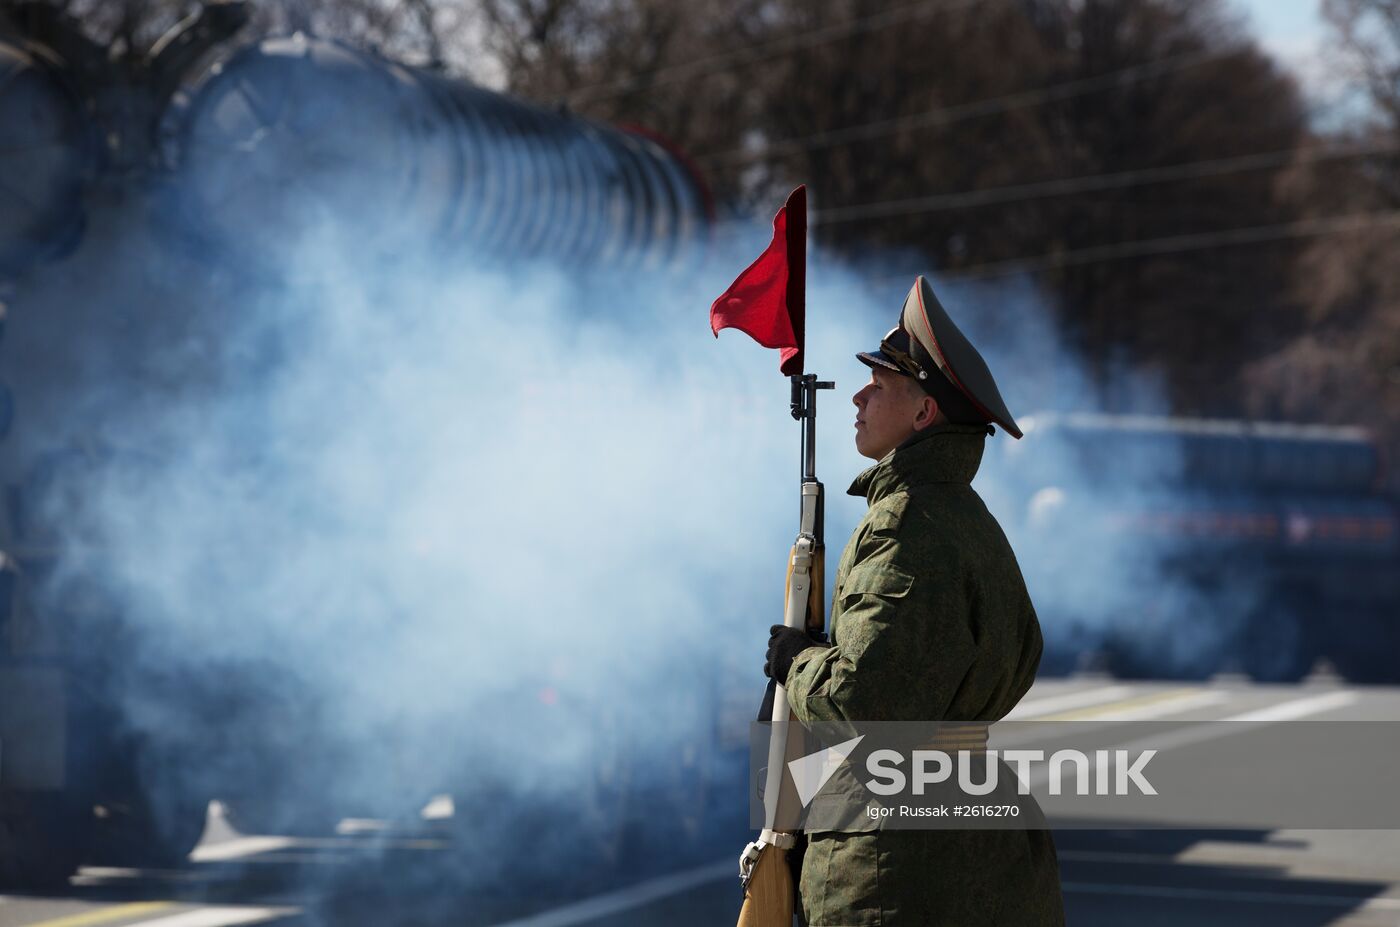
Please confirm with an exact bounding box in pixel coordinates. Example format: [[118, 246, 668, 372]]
[[710, 185, 806, 377]]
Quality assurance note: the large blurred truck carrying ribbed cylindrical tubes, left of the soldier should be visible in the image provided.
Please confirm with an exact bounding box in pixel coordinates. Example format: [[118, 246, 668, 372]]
[[0, 3, 713, 886]]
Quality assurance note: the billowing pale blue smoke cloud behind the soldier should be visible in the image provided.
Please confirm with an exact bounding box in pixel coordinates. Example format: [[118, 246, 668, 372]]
[[6, 119, 1243, 901]]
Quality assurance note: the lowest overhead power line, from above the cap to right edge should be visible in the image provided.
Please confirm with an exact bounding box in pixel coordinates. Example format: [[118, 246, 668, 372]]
[[929, 210, 1400, 280]]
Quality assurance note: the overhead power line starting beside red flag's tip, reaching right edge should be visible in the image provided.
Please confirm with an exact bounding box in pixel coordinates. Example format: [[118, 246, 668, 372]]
[[808, 143, 1400, 225]]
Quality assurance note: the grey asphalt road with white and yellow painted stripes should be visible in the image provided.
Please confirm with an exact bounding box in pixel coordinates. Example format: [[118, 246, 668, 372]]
[[0, 678, 1400, 927]]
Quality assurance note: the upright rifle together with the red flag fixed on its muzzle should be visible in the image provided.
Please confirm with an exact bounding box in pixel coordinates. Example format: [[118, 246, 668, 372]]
[[710, 186, 833, 927]]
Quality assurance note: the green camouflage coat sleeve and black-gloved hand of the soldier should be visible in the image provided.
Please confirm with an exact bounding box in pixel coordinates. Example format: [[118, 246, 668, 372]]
[[787, 532, 974, 724]]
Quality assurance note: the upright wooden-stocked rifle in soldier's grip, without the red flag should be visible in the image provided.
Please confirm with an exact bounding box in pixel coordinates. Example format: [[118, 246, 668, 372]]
[[738, 374, 836, 927]]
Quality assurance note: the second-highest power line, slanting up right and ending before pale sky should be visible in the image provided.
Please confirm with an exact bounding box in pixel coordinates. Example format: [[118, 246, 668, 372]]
[[696, 48, 1245, 164]]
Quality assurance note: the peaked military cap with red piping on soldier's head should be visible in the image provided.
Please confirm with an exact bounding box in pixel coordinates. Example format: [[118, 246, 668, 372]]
[[855, 276, 1021, 438]]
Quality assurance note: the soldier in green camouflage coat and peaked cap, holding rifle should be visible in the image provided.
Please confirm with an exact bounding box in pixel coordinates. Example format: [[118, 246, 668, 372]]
[[764, 277, 1064, 927]]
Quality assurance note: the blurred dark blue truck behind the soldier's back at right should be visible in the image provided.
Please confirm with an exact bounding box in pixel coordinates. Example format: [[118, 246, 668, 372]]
[[987, 413, 1400, 682]]
